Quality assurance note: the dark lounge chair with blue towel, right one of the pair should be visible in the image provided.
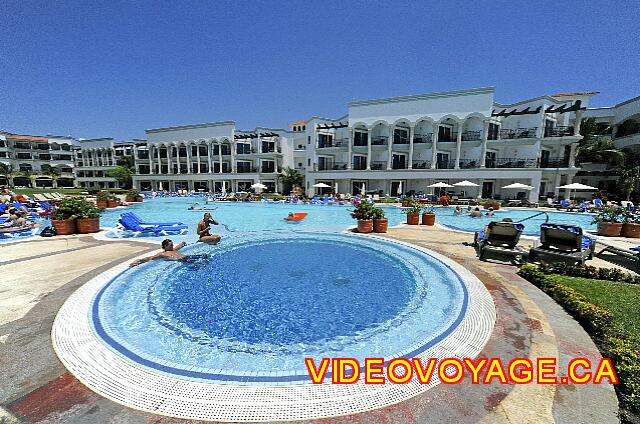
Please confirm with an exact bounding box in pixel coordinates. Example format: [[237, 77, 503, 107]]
[[529, 223, 596, 265]]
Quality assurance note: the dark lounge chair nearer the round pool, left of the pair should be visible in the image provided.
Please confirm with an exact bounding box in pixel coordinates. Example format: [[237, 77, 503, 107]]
[[474, 221, 528, 262]]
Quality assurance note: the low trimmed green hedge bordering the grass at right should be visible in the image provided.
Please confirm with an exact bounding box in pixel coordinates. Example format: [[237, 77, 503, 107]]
[[518, 264, 640, 423]]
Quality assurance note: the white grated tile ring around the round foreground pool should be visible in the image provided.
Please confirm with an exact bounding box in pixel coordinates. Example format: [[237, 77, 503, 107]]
[[52, 235, 495, 421]]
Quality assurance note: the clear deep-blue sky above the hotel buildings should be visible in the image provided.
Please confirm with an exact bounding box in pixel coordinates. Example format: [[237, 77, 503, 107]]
[[0, 0, 640, 139]]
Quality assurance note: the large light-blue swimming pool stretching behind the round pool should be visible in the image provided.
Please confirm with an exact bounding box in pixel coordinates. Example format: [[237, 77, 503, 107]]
[[101, 197, 595, 237]]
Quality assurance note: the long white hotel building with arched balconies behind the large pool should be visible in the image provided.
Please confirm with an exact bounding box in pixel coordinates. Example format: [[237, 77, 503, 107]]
[[127, 87, 596, 201]]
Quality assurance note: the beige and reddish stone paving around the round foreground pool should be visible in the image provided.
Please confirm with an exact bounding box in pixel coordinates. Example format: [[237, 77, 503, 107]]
[[0, 226, 618, 423]]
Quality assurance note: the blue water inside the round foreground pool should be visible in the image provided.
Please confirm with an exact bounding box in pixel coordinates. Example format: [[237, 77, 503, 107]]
[[91, 231, 467, 384]]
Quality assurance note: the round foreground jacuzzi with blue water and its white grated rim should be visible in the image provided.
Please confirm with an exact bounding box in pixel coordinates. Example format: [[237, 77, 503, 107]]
[[53, 232, 495, 421]]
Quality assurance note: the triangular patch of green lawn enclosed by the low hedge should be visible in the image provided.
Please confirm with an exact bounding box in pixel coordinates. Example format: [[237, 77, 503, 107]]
[[549, 275, 640, 342]]
